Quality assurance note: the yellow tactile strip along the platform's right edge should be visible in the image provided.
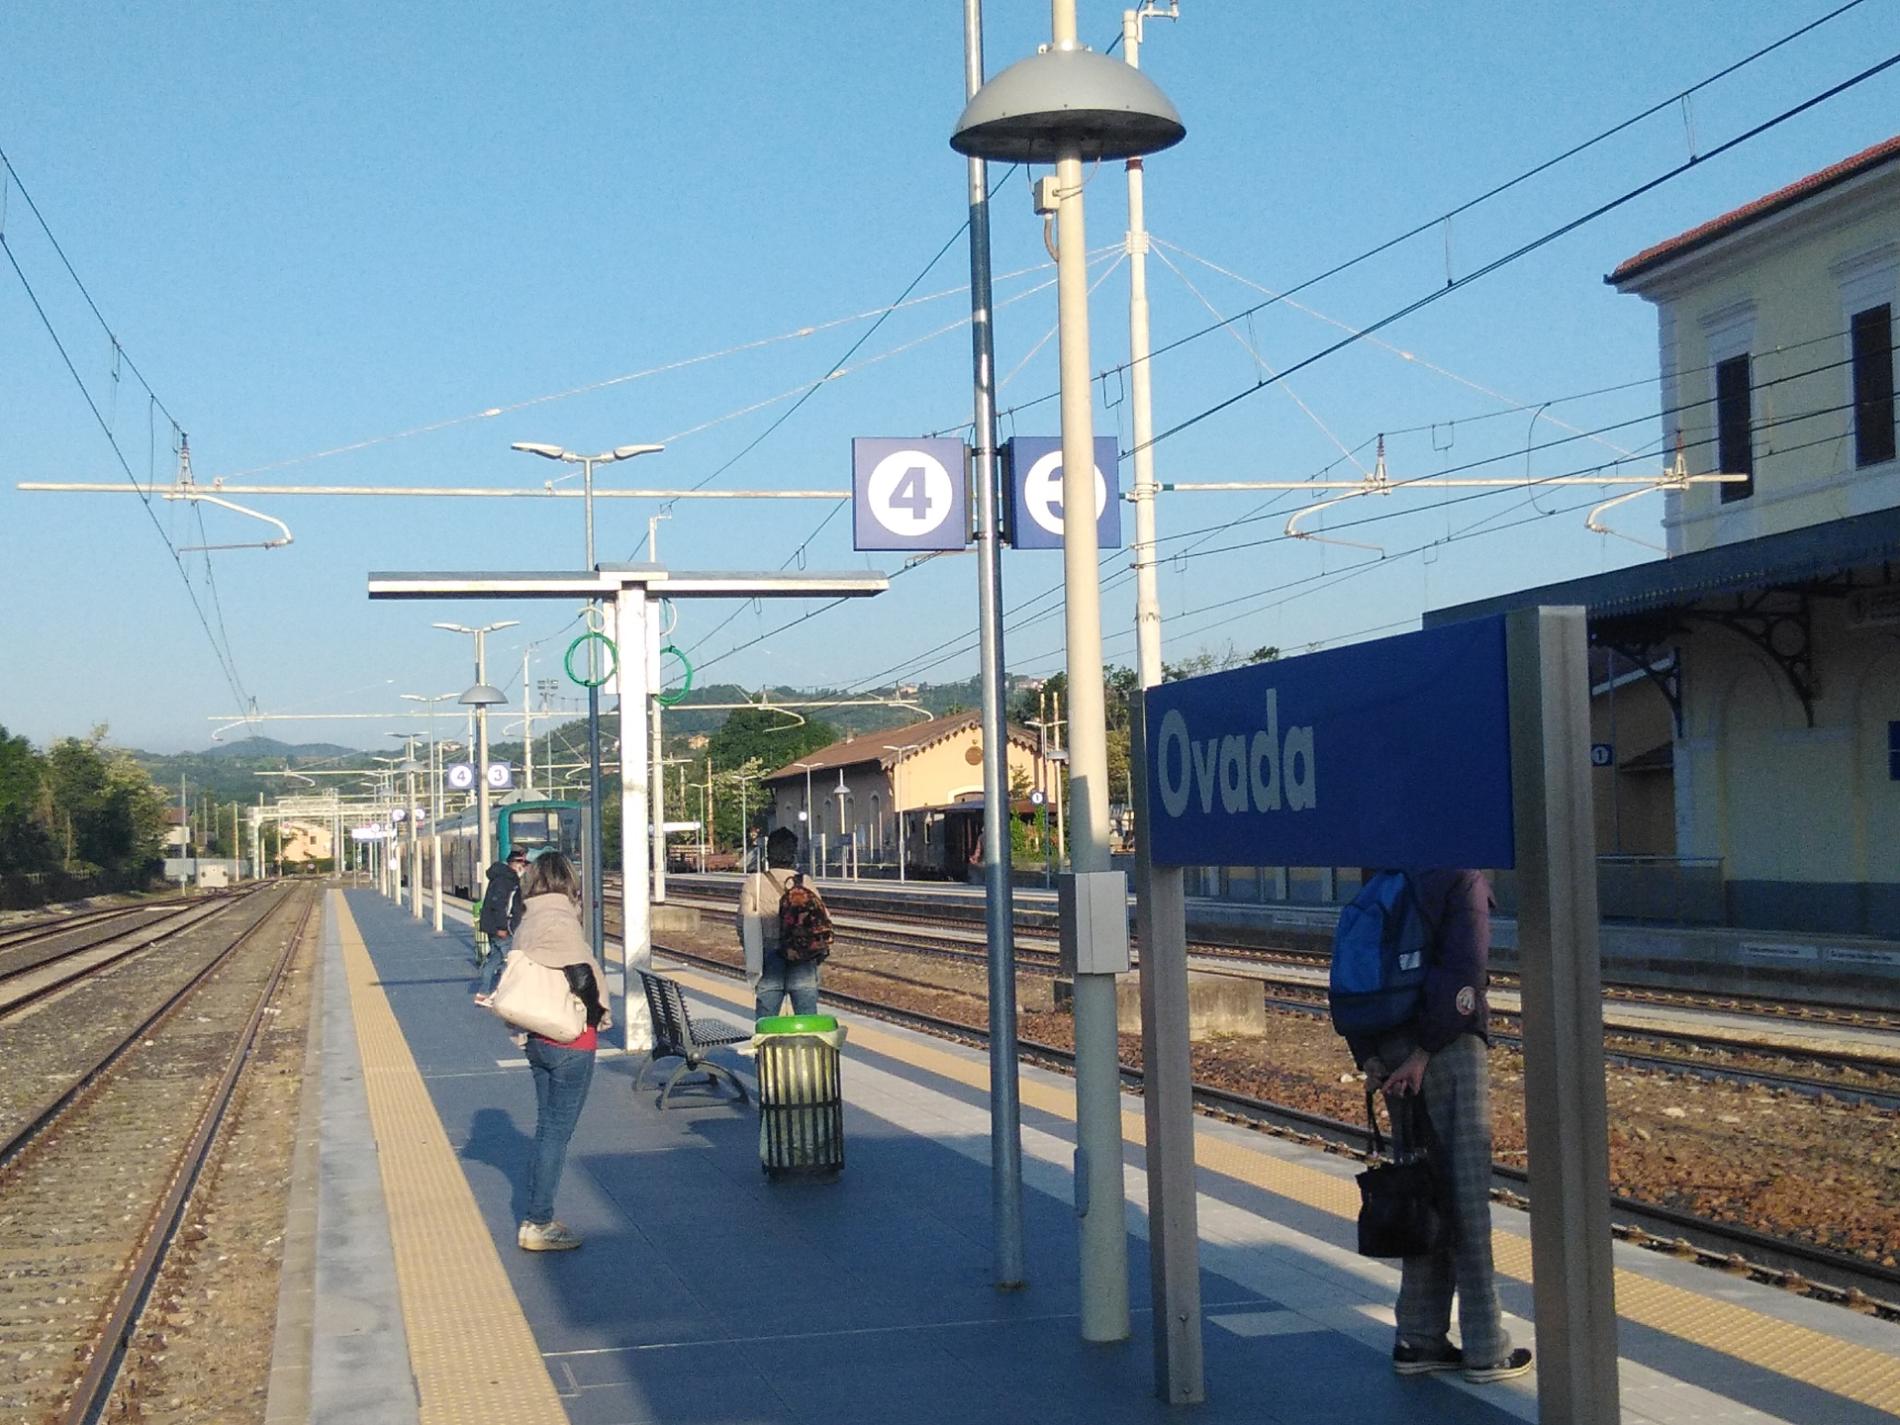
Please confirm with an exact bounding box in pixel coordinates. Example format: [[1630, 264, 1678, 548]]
[[680, 973, 1900, 1416]]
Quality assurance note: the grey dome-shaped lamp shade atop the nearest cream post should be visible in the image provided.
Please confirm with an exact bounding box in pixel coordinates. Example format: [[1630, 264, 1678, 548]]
[[950, 49, 1188, 163]]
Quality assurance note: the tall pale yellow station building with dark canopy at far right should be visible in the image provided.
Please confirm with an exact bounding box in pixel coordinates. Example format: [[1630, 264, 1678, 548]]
[[1425, 137, 1900, 937]]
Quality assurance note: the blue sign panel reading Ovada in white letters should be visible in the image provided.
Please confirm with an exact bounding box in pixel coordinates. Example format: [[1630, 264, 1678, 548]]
[[1146, 618, 1516, 868]]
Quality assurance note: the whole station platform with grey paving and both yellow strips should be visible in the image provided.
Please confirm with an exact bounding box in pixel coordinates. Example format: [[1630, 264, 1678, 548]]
[[281, 891, 1900, 1425]]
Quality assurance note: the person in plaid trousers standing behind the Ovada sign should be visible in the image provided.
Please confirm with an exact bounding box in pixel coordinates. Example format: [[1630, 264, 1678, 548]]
[[1347, 870, 1531, 1381]]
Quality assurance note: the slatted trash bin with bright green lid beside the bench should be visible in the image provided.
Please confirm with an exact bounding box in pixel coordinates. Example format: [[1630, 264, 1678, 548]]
[[752, 1015, 844, 1182]]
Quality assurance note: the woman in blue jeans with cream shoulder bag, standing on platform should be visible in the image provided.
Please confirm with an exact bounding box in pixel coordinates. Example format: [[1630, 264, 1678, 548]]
[[513, 851, 612, 1252]]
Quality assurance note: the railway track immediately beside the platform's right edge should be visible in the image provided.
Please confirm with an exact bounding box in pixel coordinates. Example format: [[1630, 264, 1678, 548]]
[[654, 944, 1900, 1321]]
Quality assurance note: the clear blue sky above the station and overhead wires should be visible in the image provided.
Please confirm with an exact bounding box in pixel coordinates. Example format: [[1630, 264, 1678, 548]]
[[0, 0, 1900, 749]]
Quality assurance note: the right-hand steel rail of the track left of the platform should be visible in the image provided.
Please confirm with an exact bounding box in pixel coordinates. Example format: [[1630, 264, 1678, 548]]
[[61, 891, 317, 1425]]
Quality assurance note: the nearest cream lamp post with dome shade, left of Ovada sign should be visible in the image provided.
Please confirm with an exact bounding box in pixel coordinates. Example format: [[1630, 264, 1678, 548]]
[[950, 0, 1186, 1341]]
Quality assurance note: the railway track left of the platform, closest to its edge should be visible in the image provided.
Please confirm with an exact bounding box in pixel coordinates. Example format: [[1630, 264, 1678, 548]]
[[0, 889, 317, 1425]]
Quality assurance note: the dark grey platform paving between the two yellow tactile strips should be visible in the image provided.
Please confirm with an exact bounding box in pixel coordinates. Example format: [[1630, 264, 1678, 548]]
[[334, 893, 1892, 1425]]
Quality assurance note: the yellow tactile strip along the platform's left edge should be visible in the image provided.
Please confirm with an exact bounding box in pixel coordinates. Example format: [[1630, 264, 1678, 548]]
[[329, 891, 568, 1425]]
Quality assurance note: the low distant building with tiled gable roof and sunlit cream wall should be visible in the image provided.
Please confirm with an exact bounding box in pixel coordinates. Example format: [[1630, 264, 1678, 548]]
[[762, 713, 1055, 882]]
